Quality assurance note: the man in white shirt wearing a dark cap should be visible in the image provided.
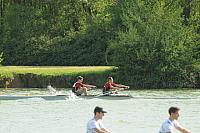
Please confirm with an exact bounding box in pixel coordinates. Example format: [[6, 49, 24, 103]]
[[86, 106, 111, 133]]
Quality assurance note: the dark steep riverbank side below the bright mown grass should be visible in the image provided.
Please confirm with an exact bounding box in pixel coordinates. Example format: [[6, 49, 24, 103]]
[[0, 67, 116, 88]]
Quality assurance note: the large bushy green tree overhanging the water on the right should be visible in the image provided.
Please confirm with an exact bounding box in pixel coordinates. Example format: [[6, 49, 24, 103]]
[[110, 0, 199, 88]]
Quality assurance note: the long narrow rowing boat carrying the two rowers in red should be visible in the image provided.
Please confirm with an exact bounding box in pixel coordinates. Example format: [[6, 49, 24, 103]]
[[0, 94, 132, 100]]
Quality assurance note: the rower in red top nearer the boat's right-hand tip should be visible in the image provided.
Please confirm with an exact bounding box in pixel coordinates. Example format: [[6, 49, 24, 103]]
[[103, 77, 130, 95]]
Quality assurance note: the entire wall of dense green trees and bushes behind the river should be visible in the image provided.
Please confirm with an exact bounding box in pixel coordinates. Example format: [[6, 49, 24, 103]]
[[0, 0, 200, 88]]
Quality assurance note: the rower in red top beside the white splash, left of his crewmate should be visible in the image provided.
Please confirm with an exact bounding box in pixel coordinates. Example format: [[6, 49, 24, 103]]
[[72, 76, 96, 96]]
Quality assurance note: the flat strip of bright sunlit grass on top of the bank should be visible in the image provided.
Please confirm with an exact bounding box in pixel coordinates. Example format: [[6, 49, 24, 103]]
[[0, 66, 116, 78]]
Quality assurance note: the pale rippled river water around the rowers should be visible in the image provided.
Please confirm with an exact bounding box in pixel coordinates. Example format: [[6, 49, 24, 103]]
[[0, 89, 200, 133]]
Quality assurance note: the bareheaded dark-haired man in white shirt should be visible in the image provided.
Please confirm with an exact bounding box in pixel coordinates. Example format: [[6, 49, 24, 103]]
[[159, 107, 191, 133]]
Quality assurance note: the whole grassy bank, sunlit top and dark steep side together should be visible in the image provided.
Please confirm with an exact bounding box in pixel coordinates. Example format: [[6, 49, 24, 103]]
[[0, 66, 117, 88]]
